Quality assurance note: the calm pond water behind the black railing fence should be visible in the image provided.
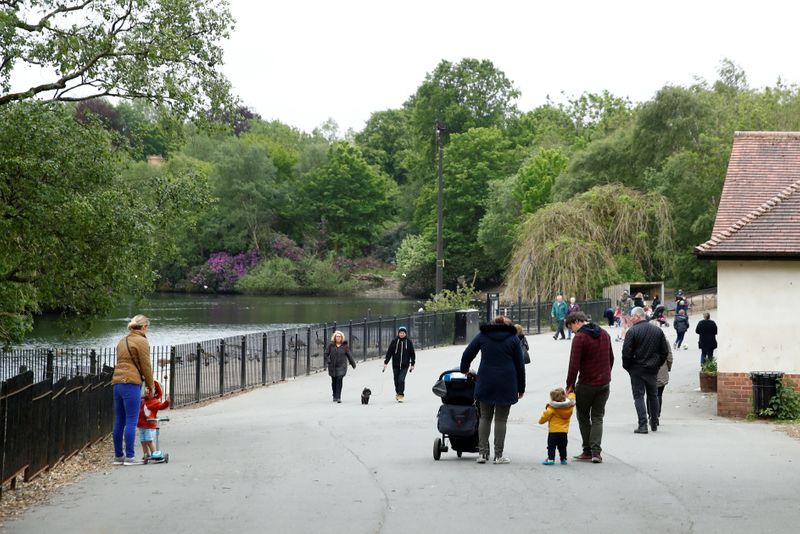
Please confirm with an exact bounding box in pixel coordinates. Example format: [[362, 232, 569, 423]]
[[23, 294, 420, 348]]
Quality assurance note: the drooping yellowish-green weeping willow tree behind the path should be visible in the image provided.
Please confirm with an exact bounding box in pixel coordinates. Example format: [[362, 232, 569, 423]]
[[505, 184, 674, 300]]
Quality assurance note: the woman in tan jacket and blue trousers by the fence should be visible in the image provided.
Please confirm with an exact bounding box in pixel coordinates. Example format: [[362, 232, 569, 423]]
[[111, 315, 153, 465]]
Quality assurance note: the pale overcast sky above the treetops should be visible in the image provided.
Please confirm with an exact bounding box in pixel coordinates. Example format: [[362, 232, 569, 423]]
[[224, 0, 800, 133]]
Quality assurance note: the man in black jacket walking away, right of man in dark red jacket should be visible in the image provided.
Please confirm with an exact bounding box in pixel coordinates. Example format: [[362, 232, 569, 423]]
[[622, 306, 669, 434]]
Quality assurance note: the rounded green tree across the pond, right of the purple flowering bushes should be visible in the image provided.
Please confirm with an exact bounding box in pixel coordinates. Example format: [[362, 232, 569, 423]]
[[299, 141, 397, 255]]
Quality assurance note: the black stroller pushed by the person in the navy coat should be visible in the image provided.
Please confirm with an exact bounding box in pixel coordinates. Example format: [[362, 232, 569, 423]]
[[433, 369, 479, 460]]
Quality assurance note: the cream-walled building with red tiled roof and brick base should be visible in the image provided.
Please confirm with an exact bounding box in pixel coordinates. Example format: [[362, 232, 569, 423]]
[[695, 132, 800, 416]]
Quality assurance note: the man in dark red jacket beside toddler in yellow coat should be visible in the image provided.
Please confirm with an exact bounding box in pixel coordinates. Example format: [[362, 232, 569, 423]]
[[565, 312, 614, 464]]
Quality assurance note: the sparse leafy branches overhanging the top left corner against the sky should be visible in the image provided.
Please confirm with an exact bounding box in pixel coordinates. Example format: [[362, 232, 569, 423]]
[[0, 0, 233, 116]]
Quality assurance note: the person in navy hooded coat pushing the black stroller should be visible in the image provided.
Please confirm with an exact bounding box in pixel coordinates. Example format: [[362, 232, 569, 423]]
[[461, 315, 525, 464]]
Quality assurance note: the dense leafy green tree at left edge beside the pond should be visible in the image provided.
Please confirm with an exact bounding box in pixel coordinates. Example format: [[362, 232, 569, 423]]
[[0, 102, 204, 343]]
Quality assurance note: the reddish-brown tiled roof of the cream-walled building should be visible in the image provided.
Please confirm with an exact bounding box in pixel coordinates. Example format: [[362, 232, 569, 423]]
[[695, 132, 800, 258]]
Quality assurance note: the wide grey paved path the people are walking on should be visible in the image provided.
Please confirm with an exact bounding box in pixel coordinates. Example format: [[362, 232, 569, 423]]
[[7, 318, 800, 534]]
